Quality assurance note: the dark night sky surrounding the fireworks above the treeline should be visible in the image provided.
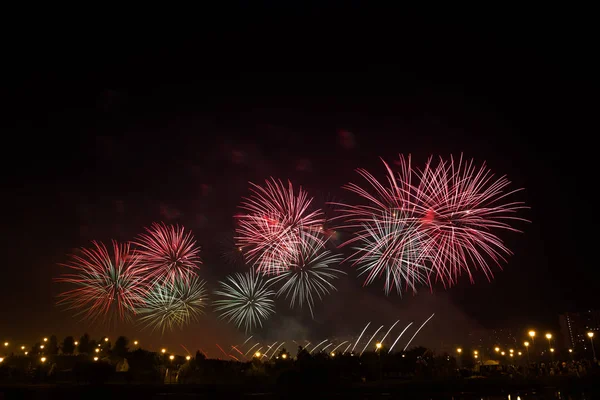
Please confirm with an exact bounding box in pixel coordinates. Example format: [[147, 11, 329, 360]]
[[0, 10, 599, 352]]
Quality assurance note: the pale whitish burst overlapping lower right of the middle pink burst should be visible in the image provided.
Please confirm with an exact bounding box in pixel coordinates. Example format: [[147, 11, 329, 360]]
[[269, 233, 344, 317]]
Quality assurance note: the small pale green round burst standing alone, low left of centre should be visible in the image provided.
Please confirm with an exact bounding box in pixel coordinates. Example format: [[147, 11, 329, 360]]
[[214, 271, 275, 332]]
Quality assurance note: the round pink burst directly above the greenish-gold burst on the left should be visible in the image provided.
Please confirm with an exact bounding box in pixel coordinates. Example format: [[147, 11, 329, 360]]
[[135, 222, 201, 282]]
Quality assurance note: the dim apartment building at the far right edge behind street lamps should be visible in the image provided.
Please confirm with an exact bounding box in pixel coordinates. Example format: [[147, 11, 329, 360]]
[[559, 310, 600, 352]]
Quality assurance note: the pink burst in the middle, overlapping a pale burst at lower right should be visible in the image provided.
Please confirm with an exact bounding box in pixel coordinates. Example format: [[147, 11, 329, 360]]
[[235, 178, 325, 274]]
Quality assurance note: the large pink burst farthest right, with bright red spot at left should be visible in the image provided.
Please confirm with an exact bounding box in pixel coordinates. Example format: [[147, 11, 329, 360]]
[[414, 155, 527, 286]]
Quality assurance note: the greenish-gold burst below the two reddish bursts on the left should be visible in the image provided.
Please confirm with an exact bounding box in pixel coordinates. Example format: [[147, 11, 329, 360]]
[[139, 276, 207, 334]]
